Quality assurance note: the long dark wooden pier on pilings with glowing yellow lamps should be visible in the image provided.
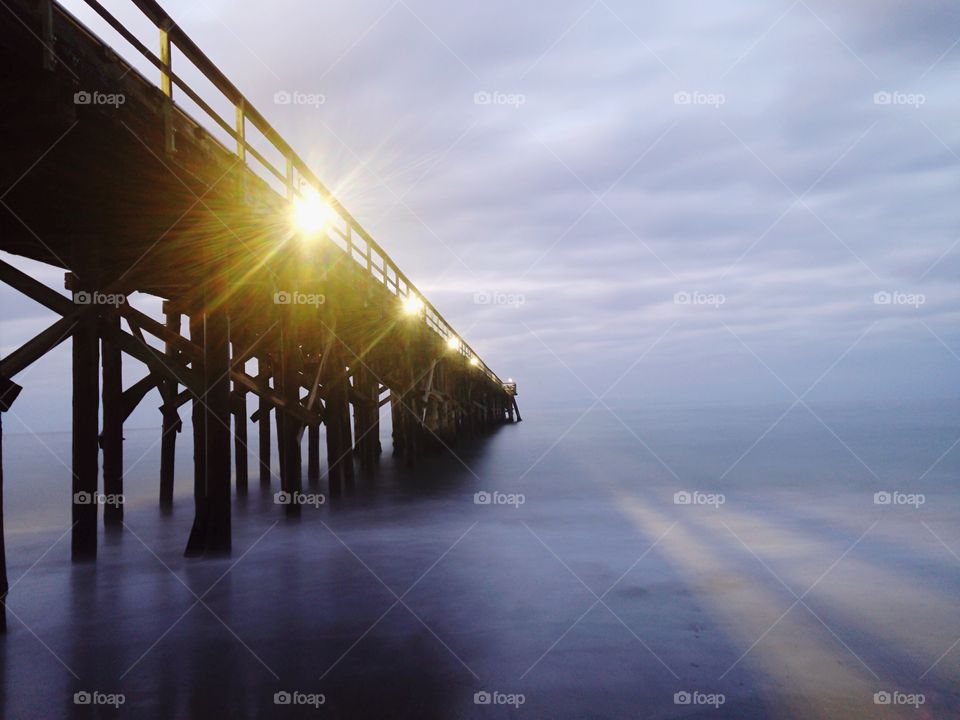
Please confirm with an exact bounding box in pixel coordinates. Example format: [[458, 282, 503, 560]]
[[0, 0, 519, 632]]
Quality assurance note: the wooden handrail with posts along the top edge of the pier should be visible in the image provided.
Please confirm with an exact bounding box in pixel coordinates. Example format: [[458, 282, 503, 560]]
[[71, 0, 503, 386]]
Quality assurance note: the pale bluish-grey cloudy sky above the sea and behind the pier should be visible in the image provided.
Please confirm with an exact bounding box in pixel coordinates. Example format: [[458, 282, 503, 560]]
[[0, 0, 960, 430]]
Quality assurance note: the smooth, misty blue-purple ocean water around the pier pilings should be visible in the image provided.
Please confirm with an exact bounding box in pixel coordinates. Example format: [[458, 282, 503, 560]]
[[0, 402, 960, 718]]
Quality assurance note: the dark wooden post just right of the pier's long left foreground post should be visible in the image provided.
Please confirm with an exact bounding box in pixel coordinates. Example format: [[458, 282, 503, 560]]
[[101, 314, 125, 525]]
